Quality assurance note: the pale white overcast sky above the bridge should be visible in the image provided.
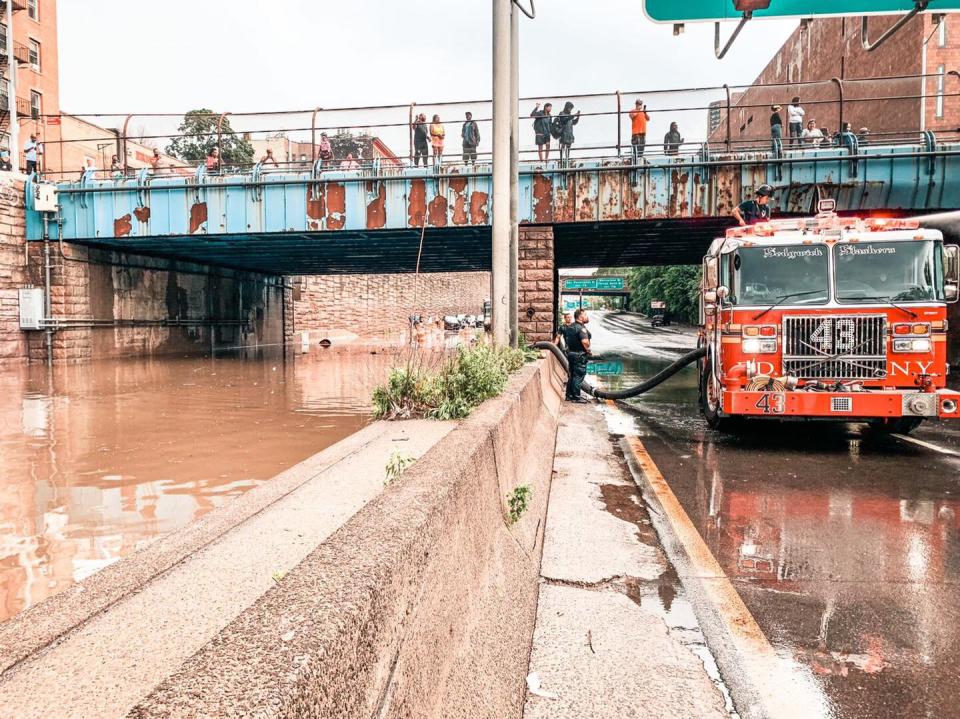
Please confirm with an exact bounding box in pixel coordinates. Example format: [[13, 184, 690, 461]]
[[58, 0, 796, 154]]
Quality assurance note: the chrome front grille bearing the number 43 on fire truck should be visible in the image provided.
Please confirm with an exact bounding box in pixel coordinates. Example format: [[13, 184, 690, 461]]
[[783, 315, 887, 379]]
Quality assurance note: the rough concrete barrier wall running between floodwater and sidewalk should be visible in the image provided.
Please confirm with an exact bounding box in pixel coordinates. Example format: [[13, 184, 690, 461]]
[[130, 358, 563, 719]]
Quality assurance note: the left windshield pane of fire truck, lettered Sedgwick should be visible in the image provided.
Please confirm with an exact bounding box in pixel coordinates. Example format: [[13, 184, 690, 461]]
[[729, 245, 830, 305]]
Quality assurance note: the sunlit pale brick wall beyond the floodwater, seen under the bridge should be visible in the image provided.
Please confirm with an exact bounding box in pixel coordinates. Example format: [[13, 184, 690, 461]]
[[286, 272, 490, 342]]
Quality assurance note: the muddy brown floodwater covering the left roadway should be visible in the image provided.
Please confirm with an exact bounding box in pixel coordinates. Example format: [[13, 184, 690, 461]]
[[0, 350, 408, 621]]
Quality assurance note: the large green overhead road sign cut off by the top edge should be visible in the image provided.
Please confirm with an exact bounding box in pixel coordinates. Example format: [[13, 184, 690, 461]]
[[643, 0, 960, 23]]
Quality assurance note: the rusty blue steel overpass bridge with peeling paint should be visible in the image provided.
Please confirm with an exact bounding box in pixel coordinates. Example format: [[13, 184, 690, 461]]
[[27, 139, 960, 275]]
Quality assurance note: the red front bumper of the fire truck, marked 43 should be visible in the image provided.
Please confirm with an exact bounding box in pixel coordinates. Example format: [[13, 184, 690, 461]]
[[723, 389, 960, 420]]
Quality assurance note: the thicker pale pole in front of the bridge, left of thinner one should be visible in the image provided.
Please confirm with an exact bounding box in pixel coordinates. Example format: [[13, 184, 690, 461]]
[[492, 0, 516, 346]]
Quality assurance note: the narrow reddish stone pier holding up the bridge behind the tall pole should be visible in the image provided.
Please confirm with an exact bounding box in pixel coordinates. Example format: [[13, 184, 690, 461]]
[[517, 227, 557, 342]]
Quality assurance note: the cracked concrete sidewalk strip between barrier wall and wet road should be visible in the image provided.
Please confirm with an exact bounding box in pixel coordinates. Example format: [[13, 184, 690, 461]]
[[524, 403, 729, 719]]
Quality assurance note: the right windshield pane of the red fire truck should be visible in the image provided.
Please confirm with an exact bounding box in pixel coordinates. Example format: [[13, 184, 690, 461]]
[[834, 240, 944, 303]]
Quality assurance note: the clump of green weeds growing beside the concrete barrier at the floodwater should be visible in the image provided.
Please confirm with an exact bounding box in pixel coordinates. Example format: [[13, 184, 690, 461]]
[[373, 344, 539, 420]]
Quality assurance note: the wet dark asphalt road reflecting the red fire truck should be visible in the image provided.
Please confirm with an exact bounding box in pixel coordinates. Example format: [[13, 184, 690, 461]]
[[591, 314, 960, 717]]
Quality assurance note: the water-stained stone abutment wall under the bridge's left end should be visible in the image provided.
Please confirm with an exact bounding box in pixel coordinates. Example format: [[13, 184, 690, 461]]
[[0, 175, 284, 363]]
